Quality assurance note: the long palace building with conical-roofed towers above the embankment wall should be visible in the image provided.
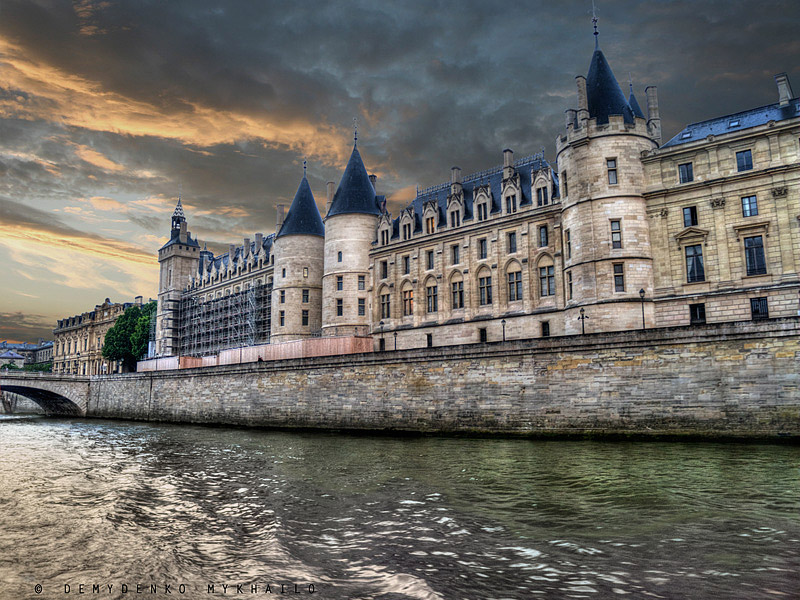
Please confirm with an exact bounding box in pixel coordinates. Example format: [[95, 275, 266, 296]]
[[156, 31, 800, 356]]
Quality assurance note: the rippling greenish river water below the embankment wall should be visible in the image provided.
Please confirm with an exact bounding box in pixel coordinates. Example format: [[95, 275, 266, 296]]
[[0, 417, 800, 600]]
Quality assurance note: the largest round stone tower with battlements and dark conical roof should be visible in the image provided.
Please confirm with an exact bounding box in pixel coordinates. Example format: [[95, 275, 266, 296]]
[[556, 33, 660, 334]]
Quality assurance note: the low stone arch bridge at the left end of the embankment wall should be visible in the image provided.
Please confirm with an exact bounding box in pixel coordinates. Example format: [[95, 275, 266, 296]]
[[0, 371, 89, 416]]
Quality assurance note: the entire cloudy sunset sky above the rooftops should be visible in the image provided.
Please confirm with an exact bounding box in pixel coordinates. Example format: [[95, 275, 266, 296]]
[[0, 0, 800, 341]]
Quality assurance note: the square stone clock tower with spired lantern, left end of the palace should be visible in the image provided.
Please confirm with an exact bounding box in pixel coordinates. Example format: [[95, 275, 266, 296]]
[[156, 198, 201, 356]]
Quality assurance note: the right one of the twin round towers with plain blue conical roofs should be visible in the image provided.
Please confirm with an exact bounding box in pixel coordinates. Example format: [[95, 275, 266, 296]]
[[322, 145, 381, 336]]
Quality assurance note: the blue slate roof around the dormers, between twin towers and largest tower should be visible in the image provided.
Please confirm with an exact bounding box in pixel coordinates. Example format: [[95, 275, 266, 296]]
[[391, 154, 560, 239]]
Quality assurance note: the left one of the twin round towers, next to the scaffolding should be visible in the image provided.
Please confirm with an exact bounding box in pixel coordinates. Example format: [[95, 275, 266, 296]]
[[270, 167, 325, 343]]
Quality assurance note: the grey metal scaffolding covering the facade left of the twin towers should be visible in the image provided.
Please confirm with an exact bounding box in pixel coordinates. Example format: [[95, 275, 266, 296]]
[[178, 284, 272, 356]]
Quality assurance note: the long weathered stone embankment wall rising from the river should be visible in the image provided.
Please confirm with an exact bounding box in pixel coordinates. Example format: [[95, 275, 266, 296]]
[[88, 318, 800, 439]]
